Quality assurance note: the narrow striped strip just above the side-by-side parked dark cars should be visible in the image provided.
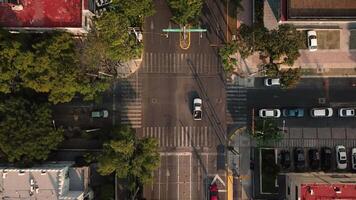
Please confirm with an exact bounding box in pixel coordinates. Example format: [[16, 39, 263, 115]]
[[271, 138, 356, 148]]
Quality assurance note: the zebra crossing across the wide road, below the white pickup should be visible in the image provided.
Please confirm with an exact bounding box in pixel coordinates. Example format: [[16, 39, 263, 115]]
[[142, 126, 217, 147]]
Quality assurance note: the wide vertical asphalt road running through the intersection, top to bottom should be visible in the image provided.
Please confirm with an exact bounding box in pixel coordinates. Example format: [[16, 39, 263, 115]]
[[137, 0, 226, 199]]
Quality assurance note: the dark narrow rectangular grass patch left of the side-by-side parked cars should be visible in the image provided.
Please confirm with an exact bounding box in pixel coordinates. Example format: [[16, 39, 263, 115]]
[[261, 149, 278, 193]]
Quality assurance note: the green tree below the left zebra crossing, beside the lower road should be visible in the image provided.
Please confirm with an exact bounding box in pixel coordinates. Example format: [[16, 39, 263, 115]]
[[97, 126, 160, 198]]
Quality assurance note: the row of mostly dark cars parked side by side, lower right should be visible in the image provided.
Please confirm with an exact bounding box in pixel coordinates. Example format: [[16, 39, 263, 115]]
[[280, 145, 356, 171]]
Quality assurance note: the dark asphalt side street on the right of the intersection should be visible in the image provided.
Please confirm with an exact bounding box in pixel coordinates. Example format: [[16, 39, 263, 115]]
[[247, 78, 356, 128]]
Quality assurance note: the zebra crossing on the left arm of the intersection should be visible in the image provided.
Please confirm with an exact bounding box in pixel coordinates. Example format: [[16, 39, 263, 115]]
[[118, 75, 142, 128]]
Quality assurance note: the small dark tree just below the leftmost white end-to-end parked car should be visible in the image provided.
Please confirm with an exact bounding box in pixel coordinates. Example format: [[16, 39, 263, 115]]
[[252, 119, 283, 145]]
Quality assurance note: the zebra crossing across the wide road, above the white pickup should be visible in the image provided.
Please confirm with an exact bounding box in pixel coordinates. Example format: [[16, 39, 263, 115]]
[[140, 52, 222, 74]]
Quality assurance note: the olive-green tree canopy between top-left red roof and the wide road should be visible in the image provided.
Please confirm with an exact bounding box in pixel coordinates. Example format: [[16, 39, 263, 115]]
[[80, 0, 155, 69]]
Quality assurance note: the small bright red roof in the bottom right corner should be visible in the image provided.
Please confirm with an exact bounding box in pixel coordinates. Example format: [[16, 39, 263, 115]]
[[301, 184, 356, 200]]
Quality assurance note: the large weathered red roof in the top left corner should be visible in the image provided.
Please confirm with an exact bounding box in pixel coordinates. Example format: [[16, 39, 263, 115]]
[[0, 0, 82, 28]]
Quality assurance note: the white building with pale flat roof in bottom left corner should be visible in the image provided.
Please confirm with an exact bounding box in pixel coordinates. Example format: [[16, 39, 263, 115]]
[[0, 162, 93, 200]]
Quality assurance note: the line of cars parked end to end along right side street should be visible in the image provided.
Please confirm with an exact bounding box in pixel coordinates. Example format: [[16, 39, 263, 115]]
[[259, 108, 355, 118]]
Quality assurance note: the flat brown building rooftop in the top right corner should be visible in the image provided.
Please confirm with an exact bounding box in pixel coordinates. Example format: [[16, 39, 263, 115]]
[[281, 0, 356, 20]]
